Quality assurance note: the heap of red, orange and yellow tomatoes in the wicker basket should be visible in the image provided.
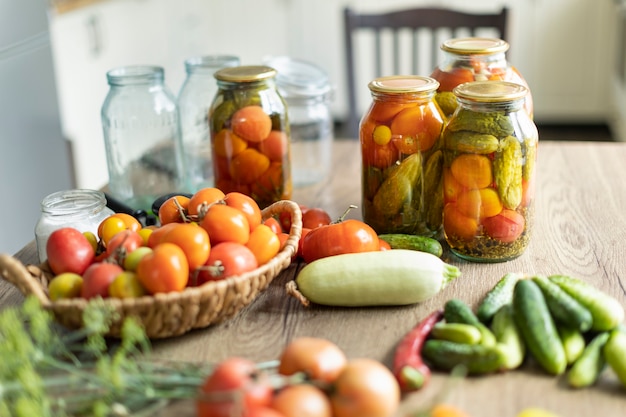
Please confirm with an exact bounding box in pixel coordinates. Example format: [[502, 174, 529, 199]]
[[46, 187, 286, 301]]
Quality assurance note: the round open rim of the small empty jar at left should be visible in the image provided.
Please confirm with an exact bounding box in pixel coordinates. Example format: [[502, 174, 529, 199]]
[[41, 189, 106, 216]]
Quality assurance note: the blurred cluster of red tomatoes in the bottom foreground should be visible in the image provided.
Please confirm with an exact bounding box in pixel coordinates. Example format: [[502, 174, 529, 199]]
[[196, 337, 400, 417]]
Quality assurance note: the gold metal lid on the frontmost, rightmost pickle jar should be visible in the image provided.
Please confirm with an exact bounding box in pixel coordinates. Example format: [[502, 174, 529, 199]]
[[452, 81, 528, 103]]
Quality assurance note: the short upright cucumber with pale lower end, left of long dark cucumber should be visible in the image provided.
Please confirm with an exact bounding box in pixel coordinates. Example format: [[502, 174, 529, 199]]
[[491, 304, 526, 369]]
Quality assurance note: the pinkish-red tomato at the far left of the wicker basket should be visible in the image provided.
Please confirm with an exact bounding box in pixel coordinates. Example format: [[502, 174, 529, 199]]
[[46, 227, 96, 275]]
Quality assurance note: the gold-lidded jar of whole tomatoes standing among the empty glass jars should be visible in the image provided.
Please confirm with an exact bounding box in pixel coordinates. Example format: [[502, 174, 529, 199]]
[[209, 66, 292, 208]]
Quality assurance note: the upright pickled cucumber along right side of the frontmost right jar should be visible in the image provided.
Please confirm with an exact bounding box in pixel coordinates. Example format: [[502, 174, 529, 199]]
[[493, 136, 524, 210]]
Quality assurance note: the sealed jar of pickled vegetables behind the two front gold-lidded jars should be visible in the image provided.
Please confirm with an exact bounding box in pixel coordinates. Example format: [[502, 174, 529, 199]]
[[431, 38, 533, 118]]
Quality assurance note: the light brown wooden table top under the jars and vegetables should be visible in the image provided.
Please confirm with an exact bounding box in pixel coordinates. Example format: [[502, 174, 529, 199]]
[[0, 140, 626, 417]]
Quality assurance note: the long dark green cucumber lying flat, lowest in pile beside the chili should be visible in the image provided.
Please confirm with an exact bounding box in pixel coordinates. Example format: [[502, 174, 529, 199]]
[[422, 339, 505, 374]]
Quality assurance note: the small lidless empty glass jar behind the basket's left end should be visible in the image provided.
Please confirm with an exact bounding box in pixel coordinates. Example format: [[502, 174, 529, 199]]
[[35, 189, 113, 262]]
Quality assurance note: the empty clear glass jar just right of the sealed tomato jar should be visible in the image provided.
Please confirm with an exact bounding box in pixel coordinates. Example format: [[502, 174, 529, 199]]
[[266, 56, 334, 187]]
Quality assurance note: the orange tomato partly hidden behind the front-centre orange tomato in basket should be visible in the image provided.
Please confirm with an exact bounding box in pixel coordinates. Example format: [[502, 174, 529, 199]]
[[161, 223, 211, 271]]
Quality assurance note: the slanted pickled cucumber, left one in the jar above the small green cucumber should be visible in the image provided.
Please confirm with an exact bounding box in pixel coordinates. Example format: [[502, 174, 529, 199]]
[[372, 152, 422, 216]]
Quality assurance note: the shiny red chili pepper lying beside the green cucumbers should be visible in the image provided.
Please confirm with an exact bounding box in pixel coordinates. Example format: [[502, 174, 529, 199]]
[[393, 310, 443, 391]]
